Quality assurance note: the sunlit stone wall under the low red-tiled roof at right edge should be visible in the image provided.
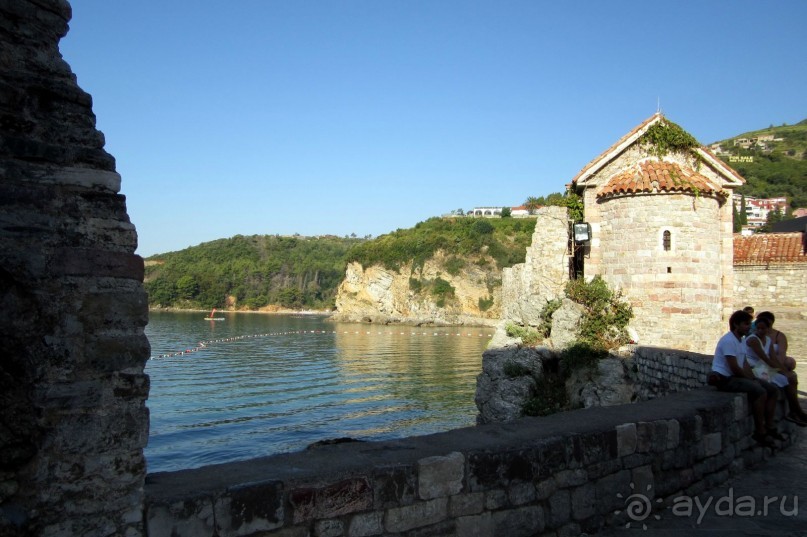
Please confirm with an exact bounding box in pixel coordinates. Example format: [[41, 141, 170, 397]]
[[733, 263, 807, 312]]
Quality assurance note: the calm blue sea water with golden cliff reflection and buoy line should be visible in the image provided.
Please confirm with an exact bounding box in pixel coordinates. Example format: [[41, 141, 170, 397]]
[[146, 312, 491, 472]]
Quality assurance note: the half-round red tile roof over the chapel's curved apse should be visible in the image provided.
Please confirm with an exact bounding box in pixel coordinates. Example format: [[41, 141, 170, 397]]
[[597, 160, 728, 198]]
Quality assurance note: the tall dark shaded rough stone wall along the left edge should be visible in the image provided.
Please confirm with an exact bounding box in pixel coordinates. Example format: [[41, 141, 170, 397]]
[[0, 0, 149, 535]]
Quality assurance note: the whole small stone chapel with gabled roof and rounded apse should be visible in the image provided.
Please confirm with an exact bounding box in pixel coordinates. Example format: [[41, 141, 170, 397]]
[[572, 114, 745, 353]]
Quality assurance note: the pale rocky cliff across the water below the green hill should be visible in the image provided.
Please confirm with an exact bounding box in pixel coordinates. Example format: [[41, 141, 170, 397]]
[[333, 251, 501, 325]]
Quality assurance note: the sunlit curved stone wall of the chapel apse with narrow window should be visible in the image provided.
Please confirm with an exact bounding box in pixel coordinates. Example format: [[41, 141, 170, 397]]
[[585, 194, 723, 352]]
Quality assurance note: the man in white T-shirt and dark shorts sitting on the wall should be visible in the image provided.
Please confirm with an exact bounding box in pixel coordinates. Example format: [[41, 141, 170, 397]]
[[709, 310, 779, 448]]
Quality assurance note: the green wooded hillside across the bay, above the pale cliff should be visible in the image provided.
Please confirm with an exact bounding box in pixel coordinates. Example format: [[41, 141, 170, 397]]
[[145, 218, 535, 309]]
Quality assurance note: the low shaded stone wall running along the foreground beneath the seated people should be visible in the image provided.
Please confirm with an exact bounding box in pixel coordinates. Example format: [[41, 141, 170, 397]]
[[146, 389, 795, 537]]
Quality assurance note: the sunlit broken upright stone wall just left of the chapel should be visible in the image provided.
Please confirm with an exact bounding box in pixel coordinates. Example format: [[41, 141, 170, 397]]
[[502, 207, 569, 326]]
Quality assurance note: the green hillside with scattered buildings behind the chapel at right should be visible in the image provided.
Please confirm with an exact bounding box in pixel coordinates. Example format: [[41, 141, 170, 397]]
[[716, 120, 807, 209]]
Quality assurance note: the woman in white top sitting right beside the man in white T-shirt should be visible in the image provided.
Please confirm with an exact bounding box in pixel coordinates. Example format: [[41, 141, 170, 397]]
[[744, 314, 807, 430]]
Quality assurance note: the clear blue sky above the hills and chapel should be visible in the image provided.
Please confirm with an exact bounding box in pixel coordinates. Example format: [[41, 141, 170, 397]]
[[60, 0, 807, 256]]
